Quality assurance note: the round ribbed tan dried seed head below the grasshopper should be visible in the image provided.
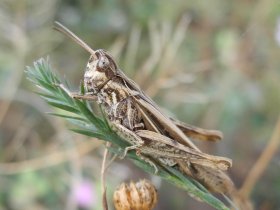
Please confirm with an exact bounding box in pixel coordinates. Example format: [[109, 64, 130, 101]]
[[114, 179, 157, 210]]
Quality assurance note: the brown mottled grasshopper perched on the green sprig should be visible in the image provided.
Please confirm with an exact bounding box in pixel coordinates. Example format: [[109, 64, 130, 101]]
[[55, 22, 232, 193]]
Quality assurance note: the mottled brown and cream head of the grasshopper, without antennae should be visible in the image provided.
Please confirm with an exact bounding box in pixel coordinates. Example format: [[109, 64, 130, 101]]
[[84, 50, 117, 93]]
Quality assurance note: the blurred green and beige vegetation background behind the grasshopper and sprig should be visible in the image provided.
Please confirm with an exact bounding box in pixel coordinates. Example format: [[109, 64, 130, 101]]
[[0, 0, 280, 210]]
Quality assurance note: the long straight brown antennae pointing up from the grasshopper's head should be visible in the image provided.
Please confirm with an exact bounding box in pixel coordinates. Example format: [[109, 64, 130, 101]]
[[53, 21, 96, 57]]
